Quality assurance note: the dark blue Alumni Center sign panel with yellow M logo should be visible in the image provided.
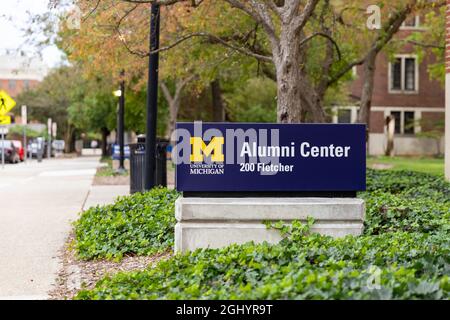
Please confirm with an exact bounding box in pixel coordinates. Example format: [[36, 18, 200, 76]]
[[172, 122, 366, 192]]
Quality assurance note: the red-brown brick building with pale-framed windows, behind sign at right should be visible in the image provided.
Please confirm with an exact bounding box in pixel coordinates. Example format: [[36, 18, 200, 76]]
[[333, 16, 445, 155]]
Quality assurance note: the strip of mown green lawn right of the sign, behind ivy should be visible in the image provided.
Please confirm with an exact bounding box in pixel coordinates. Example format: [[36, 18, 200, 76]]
[[367, 156, 444, 175]]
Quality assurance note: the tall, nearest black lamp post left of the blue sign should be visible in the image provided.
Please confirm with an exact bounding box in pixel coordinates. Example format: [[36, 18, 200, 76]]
[[144, 2, 160, 190]]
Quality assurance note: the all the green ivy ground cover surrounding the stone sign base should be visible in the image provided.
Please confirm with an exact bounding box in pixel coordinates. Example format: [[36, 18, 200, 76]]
[[73, 170, 450, 299]]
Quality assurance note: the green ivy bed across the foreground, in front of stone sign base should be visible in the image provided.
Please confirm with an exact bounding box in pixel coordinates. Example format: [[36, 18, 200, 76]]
[[77, 223, 450, 299]]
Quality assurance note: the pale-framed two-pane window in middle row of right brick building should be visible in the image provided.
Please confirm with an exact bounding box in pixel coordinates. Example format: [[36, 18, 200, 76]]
[[389, 55, 419, 93]]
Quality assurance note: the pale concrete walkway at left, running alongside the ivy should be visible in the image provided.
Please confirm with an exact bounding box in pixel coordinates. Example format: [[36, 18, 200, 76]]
[[0, 158, 128, 299]]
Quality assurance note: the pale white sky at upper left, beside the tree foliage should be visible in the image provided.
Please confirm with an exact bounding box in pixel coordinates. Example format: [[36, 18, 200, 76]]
[[0, 0, 66, 67]]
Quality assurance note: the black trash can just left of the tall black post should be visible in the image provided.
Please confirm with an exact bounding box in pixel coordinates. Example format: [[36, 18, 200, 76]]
[[130, 142, 145, 193]]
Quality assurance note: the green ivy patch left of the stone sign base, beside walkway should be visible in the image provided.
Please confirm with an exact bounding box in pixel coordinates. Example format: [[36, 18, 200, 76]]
[[75, 188, 178, 259]]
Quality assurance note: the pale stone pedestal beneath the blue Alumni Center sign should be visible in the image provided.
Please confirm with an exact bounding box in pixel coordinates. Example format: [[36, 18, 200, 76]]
[[175, 197, 365, 252]]
